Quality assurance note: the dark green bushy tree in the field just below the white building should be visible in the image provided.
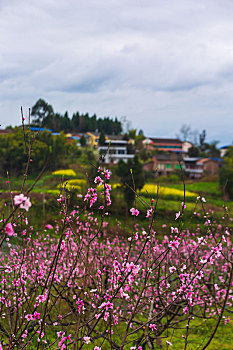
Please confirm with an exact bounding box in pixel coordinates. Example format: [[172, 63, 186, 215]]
[[116, 156, 145, 208]]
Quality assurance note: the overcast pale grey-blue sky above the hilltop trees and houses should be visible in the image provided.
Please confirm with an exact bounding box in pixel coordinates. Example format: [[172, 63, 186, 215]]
[[0, 0, 233, 145]]
